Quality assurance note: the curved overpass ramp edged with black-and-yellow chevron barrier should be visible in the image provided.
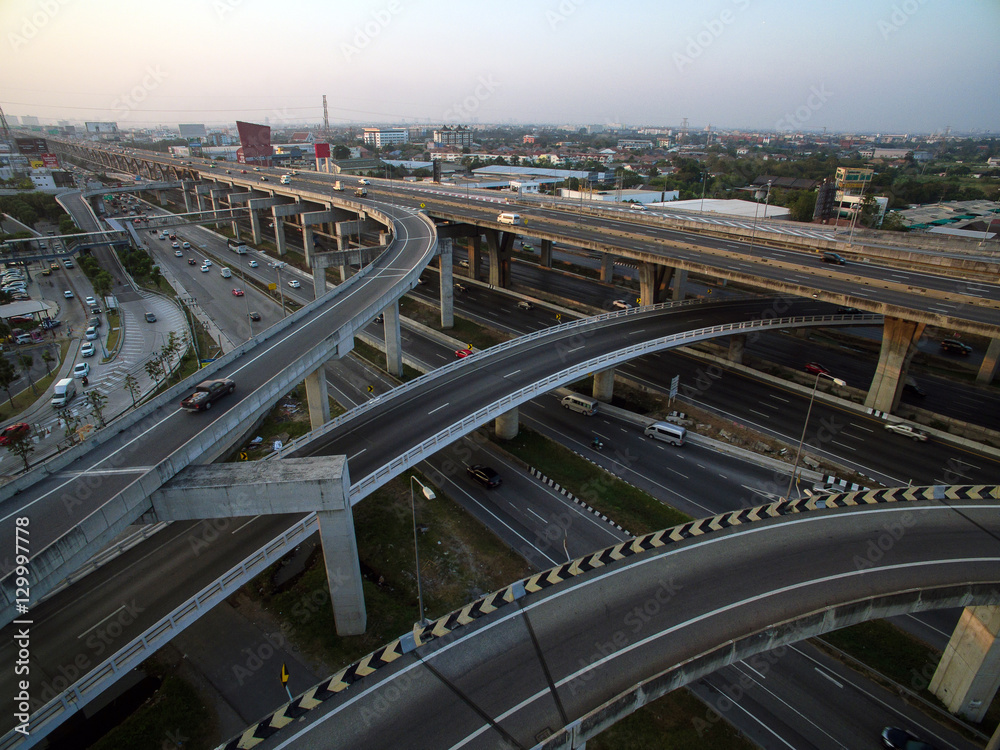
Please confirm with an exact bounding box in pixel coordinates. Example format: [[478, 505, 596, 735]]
[[225, 486, 1000, 750]]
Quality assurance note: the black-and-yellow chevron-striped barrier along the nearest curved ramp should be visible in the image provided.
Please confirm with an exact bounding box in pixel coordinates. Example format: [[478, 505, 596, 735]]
[[217, 484, 1000, 750]]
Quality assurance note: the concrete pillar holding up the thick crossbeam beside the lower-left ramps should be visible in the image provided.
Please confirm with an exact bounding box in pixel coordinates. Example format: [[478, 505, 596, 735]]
[[316, 503, 368, 635]]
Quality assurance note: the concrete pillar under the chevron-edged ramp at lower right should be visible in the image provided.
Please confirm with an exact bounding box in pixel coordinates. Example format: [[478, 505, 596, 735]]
[[929, 606, 1000, 722]]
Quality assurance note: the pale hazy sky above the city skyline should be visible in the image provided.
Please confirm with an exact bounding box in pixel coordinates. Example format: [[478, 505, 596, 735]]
[[0, 0, 1000, 133]]
